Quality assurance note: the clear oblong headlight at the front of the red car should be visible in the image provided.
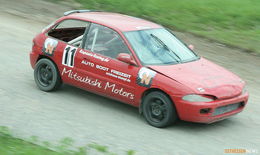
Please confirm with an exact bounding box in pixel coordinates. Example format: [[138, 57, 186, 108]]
[[182, 94, 215, 102]]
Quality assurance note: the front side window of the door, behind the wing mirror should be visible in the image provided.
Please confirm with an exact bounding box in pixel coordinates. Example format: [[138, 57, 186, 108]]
[[84, 24, 130, 58]]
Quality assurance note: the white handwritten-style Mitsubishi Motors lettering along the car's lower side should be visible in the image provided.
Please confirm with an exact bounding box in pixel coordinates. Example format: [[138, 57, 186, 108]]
[[61, 68, 134, 99]]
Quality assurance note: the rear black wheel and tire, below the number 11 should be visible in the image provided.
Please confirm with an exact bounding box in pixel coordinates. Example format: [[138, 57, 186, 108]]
[[34, 58, 62, 92]]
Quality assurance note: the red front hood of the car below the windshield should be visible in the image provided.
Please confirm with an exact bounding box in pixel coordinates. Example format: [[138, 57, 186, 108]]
[[149, 58, 244, 99]]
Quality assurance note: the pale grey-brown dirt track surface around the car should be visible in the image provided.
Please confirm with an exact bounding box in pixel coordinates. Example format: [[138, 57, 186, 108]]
[[0, 0, 260, 155]]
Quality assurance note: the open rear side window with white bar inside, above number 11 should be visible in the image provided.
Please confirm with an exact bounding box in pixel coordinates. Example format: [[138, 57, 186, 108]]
[[48, 19, 90, 47]]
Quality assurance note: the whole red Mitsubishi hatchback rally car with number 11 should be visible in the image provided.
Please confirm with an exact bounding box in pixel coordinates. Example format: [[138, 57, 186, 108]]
[[30, 10, 248, 127]]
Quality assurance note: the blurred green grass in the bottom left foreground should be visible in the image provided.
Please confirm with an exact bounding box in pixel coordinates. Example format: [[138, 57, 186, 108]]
[[0, 126, 135, 155]]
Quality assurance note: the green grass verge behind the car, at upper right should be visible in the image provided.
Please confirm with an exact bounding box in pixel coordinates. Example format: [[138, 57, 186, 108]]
[[76, 0, 260, 53]]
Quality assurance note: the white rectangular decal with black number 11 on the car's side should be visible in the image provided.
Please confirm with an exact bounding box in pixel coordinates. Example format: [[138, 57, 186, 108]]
[[62, 45, 77, 67]]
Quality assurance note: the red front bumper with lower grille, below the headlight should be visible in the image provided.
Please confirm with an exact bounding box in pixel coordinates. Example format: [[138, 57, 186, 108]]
[[172, 93, 248, 123]]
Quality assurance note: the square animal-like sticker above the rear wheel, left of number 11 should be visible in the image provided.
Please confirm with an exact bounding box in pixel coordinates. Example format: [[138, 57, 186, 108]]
[[42, 38, 58, 56]]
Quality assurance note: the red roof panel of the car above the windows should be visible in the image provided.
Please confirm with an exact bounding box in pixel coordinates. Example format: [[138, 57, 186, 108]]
[[66, 12, 162, 32]]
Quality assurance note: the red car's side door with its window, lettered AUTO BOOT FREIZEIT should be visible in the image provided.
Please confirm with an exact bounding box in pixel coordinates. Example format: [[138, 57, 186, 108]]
[[79, 23, 140, 103]]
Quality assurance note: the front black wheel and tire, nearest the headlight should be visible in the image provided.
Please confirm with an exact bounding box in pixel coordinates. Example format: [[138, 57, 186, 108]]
[[142, 91, 178, 128]]
